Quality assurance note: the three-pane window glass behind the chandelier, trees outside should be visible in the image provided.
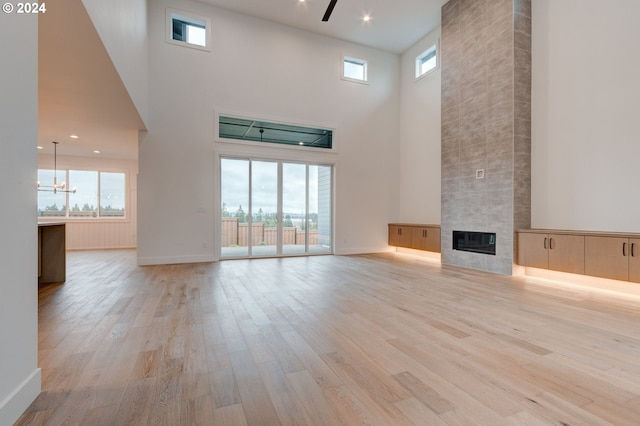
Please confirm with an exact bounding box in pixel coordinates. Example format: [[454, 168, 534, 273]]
[[38, 169, 126, 219]]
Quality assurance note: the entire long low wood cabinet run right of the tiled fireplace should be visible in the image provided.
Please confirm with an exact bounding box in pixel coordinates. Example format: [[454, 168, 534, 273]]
[[517, 229, 640, 283]]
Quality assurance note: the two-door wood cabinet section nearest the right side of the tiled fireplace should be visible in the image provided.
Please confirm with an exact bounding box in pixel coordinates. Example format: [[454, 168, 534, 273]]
[[518, 232, 584, 274]]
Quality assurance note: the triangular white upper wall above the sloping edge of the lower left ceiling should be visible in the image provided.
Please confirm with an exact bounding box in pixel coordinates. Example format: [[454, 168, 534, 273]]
[[82, 0, 149, 123]]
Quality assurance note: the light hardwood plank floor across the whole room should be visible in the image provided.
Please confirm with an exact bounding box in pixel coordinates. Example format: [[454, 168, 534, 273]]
[[17, 251, 640, 426]]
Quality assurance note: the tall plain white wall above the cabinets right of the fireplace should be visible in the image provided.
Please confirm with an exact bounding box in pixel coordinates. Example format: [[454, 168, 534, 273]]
[[531, 0, 640, 232]]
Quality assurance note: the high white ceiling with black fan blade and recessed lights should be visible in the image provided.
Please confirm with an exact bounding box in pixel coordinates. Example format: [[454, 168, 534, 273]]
[[200, 0, 448, 53]]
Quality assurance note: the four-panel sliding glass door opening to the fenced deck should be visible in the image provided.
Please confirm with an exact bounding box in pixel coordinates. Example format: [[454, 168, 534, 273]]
[[220, 158, 333, 258]]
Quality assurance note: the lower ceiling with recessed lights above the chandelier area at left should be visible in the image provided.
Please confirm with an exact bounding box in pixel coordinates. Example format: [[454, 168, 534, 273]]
[[38, 0, 144, 159]]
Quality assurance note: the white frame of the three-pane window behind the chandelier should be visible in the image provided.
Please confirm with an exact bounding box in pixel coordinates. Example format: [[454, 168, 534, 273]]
[[36, 167, 131, 222]]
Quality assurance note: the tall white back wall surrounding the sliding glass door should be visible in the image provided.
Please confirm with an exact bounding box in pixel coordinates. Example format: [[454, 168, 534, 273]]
[[138, 0, 399, 263]]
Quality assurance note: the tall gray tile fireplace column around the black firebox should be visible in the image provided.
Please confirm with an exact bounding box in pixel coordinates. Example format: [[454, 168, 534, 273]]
[[441, 0, 531, 275]]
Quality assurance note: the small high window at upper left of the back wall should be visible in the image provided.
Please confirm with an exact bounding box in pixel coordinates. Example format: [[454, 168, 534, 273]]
[[166, 9, 211, 50]]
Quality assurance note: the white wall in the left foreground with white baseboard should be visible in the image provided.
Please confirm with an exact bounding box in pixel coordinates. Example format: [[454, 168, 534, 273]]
[[0, 13, 40, 425]]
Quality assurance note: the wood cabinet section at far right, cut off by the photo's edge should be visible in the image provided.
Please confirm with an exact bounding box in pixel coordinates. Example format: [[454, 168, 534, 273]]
[[585, 236, 640, 282]]
